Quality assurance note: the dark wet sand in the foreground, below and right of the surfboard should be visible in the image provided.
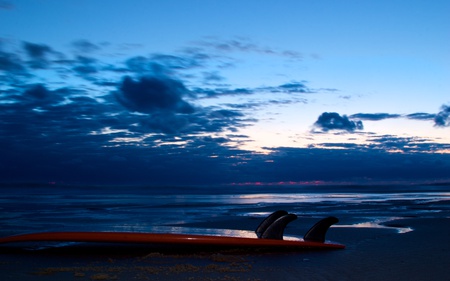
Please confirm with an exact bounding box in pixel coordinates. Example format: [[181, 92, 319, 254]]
[[0, 218, 450, 280]]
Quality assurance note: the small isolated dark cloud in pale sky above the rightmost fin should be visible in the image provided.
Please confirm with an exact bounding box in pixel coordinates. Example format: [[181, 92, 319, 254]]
[[314, 112, 363, 132]]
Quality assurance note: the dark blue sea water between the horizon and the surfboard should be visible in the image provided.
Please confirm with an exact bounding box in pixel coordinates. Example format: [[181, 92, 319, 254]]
[[0, 185, 450, 240]]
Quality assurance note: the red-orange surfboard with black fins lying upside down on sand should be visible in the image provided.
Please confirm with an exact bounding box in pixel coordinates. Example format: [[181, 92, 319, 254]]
[[0, 210, 345, 250]]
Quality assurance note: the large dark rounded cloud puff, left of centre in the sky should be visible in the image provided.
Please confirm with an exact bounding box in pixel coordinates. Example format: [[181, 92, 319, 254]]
[[116, 76, 194, 114]]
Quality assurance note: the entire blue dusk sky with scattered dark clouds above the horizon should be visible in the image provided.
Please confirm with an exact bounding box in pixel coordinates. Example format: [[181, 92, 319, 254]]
[[0, 0, 450, 186]]
